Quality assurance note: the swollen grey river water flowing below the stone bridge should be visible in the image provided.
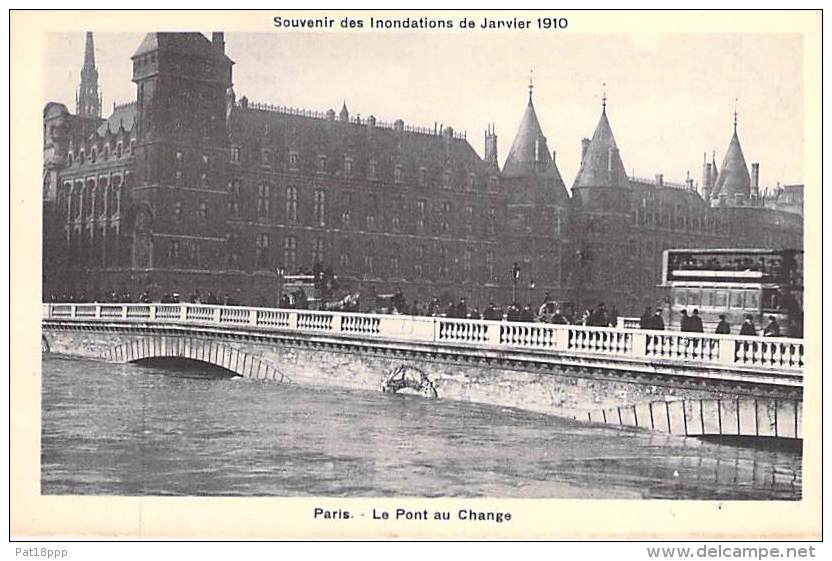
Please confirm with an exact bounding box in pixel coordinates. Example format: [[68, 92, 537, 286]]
[[41, 355, 801, 500]]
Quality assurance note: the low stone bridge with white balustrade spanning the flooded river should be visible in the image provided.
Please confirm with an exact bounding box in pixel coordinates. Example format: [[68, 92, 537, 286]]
[[42, 304, 804, 438]]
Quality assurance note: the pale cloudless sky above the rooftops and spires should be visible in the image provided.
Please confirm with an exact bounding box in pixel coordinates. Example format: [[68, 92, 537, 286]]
[[44, 30, 804, 188]]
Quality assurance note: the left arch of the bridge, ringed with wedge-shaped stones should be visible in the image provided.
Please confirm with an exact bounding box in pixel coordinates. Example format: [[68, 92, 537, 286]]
[[100, 336, 291, 382]]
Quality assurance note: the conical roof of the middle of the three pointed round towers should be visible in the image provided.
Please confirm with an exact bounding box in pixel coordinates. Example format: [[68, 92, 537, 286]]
[[572, 106, 629, 189]]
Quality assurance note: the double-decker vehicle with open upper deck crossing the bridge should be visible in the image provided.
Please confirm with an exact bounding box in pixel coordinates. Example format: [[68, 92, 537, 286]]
[[662, 249, 803, 337]]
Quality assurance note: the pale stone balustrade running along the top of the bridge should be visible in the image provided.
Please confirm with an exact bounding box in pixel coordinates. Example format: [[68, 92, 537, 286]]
[[43, 304, 804, 374]]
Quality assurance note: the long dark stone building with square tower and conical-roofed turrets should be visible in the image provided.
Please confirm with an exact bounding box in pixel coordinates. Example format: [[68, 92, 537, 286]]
[[43, 33, 803, 313]]
